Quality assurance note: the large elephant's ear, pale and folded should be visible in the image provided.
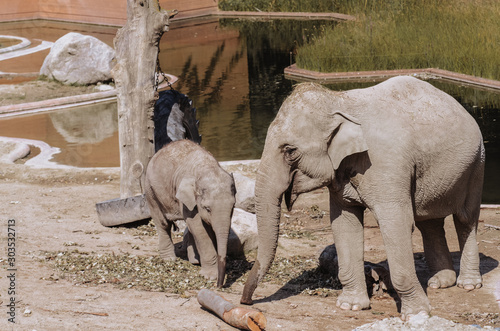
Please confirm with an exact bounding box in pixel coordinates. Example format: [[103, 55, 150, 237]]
[[328, 113, 368, 170]]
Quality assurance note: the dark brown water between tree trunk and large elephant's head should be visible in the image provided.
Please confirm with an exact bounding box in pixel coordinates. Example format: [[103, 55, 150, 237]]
[[160, 19, 337, 161]]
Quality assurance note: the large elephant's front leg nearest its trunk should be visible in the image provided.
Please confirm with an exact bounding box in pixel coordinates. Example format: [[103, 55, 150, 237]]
[[330, 204, 370, 310]]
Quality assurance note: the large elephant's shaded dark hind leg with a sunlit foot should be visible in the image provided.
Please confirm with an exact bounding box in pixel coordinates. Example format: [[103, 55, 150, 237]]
[[416, 218, 457, 288]]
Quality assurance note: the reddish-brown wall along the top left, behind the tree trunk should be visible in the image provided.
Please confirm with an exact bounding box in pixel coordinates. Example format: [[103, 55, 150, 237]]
[[0, 0, 218, 25]]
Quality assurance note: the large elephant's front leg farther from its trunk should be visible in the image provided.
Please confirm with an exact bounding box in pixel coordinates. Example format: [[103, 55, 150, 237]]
[[374, 203, 431, 320]]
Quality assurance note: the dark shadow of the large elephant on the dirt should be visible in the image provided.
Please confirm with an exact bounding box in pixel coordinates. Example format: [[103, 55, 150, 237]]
[[254, 251, 499, 311]]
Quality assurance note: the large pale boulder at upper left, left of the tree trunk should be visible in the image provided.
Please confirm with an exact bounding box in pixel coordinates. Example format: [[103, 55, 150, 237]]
[[40, 32, 115, 85]]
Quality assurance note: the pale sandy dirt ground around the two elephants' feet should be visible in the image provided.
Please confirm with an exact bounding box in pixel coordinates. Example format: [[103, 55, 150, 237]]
[[0, 83, 500, 330]]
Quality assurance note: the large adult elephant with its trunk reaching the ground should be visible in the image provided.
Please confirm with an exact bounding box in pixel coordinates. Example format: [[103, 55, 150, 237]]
[[241, 77, 485, 319]]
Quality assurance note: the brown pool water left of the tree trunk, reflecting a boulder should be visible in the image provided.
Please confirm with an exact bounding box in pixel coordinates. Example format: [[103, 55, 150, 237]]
[[0, 102, 120, 167]]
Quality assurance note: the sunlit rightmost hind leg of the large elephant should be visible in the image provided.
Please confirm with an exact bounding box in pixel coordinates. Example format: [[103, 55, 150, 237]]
[[453, 211, 482, 290]]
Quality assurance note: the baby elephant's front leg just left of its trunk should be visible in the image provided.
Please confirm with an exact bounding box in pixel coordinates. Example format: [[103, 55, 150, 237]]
[[186, 214, 218, 279]]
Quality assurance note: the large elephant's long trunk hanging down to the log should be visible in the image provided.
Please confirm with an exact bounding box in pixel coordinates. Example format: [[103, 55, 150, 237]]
[[240, 153, 290, 305]]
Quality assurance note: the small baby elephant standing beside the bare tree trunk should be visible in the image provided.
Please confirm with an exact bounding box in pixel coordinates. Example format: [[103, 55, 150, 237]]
[[146, 140, 236, 287]]
